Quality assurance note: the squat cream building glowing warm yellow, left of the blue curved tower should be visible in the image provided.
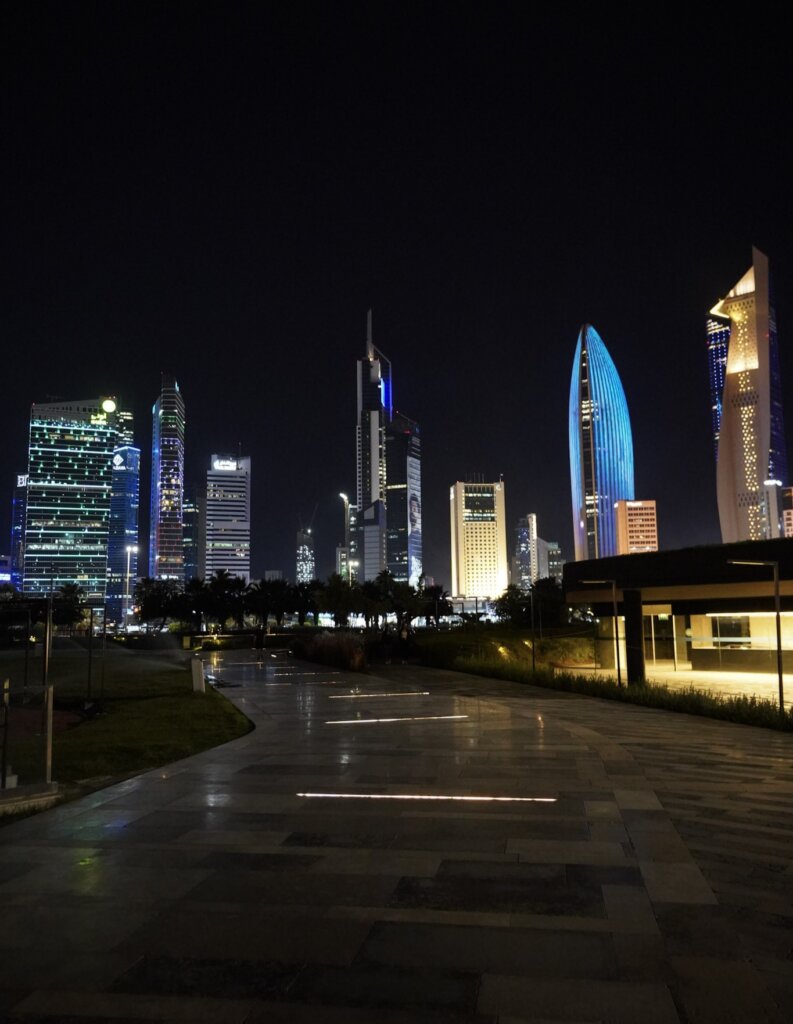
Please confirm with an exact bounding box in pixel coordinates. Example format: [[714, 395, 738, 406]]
[[449, 480, 509, 599]]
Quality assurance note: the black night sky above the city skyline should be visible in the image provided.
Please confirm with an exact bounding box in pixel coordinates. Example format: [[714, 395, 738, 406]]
[[0, 2, 793, 586]]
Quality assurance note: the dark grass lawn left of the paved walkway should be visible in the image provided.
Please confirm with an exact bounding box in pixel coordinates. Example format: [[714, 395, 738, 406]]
[[0, 643, 252, 798]]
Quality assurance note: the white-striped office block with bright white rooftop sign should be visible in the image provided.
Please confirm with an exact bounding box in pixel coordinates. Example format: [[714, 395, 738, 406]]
[[203, 455, 251, 583]]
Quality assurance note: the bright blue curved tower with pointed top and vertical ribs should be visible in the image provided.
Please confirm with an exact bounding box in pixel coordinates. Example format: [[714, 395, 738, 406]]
[[569, 324, 633, 561]]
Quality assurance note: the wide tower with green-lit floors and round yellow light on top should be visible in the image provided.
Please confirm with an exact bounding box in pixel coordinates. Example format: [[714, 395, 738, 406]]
[[23, 398, 123, 601]]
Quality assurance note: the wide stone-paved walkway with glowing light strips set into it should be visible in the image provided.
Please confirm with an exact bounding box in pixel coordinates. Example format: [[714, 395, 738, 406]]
[[0, 654, 793, 1024]]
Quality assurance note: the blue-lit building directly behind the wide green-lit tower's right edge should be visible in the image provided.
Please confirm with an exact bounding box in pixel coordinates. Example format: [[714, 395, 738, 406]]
[[107, 444, 140, 627]]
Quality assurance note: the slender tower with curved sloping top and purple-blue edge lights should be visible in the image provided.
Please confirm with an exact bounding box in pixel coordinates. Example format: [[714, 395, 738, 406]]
[[149, 374, 184, 581]]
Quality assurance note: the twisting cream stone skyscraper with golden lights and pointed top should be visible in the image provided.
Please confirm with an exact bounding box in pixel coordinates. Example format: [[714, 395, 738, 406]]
[[710, 248, 788, 544]]
